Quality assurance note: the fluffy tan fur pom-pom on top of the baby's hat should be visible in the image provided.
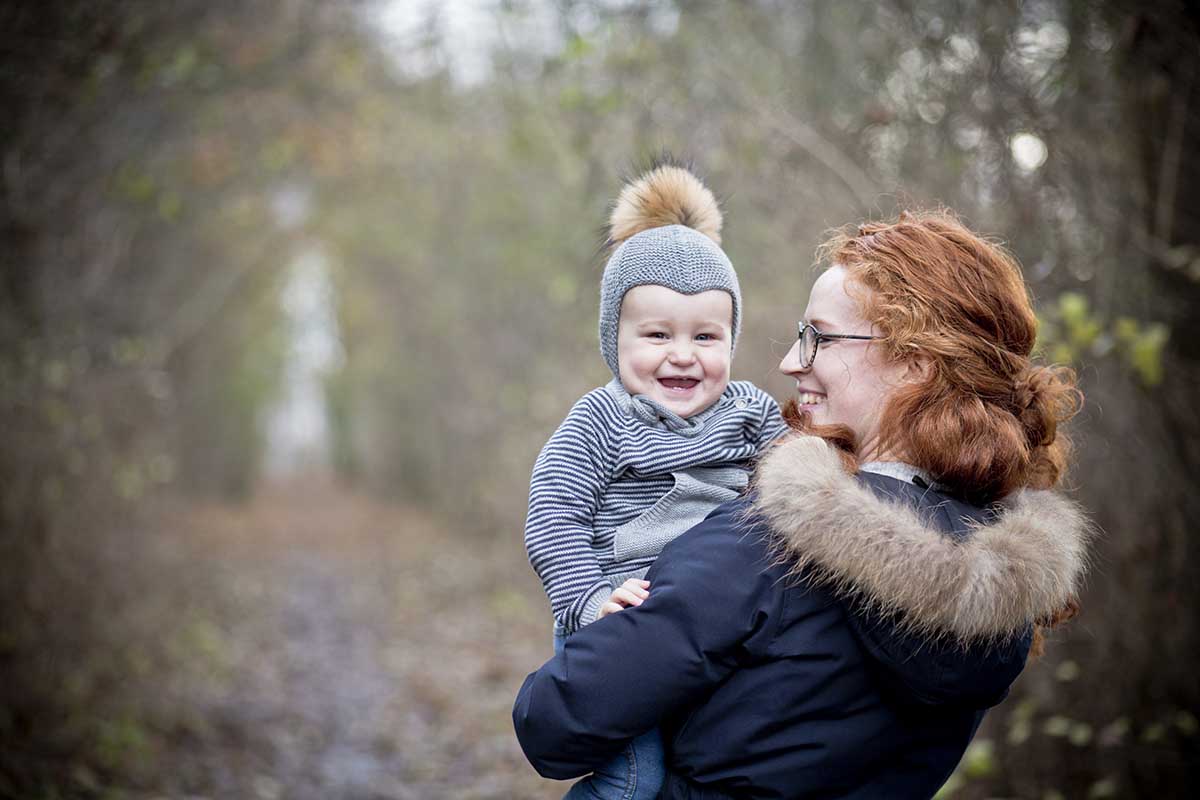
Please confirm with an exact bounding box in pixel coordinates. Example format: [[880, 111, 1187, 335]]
[[608, 164, 721, 245]]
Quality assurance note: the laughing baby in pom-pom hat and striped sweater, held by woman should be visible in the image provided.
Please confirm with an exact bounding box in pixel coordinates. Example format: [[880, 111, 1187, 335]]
[[524, 163, 786, 799]]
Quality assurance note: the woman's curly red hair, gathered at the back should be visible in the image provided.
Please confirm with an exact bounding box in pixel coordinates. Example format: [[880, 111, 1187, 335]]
[[788, 210, 1082, 505]]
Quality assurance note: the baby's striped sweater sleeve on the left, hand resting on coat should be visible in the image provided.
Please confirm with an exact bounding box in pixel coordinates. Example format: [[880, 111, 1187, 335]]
[[524, 393, 613, 633]]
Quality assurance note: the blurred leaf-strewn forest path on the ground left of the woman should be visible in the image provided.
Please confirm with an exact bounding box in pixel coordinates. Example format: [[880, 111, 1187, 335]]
[[147, 481, 564, 800]]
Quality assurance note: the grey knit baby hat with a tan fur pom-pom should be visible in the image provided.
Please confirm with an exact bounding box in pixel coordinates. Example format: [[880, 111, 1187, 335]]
[[600, 164, 742, 379]]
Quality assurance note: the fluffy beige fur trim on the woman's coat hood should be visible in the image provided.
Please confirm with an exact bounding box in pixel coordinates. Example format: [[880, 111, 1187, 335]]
[[754, 437, 1094, 640]]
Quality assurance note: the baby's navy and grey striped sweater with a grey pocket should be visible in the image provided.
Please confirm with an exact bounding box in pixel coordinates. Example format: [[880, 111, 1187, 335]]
[[524, 380, 786, 633]]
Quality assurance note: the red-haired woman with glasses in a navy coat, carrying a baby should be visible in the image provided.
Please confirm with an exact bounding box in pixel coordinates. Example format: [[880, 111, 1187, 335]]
[[514, 212, 1088, 799]]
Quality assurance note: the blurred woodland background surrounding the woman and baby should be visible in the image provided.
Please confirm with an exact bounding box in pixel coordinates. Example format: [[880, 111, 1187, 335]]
[[0, 0, 1200, 800]]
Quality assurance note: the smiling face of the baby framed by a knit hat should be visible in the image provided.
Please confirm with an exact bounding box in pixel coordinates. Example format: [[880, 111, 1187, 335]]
[[617, 285, 733, 419]]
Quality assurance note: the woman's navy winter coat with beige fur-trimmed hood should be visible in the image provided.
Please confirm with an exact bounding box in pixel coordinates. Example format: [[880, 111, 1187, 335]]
[[512, 438, 1086, 799]]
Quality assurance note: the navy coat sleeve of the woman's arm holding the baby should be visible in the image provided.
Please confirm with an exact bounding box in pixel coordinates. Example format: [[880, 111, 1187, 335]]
[[512, 503, 779, 778]]
